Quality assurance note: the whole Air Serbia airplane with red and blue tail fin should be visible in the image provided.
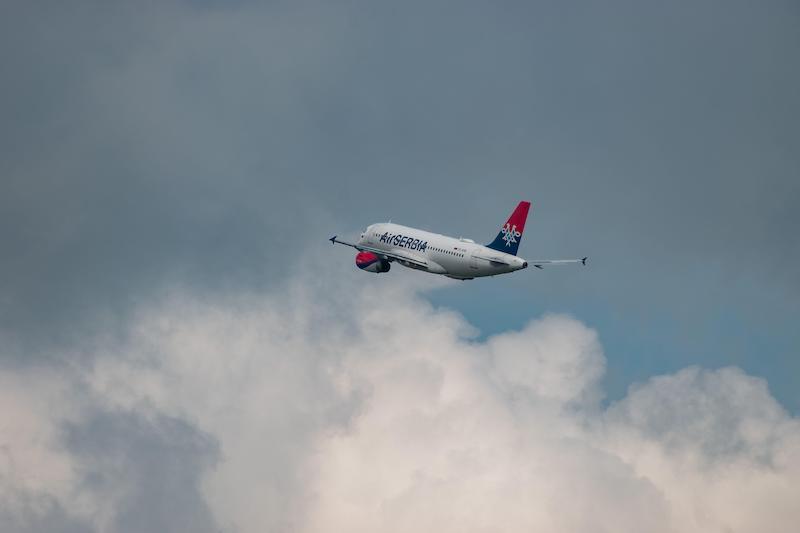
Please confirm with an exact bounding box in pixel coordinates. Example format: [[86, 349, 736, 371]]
[[328, 201, 588, 280]]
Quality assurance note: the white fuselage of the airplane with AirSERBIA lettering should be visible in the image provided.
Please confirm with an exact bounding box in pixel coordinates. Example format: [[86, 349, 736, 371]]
[[358, 223, 528, 279]]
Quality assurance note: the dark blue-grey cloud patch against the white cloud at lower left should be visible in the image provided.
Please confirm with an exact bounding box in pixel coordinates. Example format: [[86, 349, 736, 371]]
[[65, 411, 219, 533]]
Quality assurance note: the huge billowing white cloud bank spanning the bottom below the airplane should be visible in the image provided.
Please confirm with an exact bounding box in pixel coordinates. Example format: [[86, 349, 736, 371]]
[[0, 277, 800, 533]]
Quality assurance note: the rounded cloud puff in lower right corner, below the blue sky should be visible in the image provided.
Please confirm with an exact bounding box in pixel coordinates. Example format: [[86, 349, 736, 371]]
[[604, 367, 800, 532]]
